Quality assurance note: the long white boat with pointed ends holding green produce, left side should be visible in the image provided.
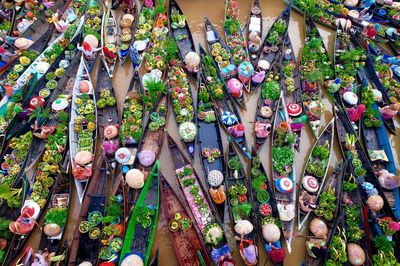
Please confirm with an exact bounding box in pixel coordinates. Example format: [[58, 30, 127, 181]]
[[69, 55, 97, 202]]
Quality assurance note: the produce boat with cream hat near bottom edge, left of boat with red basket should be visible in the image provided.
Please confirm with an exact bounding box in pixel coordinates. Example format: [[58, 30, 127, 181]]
[[225, 142, 258, 265]]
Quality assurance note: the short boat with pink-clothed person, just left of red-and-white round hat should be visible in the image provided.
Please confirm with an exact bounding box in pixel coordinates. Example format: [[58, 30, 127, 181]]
[[253, 61, 281, 151]]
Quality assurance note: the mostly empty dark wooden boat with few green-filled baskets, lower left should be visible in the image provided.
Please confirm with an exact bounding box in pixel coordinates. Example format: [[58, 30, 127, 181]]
[[68, 158, 107, 266]]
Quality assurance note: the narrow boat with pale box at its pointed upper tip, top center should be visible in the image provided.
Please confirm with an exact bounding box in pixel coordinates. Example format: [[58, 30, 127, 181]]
[[205, 17, 246, 110]]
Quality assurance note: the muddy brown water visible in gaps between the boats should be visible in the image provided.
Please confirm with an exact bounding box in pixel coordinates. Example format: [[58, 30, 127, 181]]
[[22, 0, 400, 266]]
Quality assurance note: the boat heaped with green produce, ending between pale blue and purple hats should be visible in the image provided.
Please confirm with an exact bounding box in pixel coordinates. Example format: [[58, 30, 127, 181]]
[[119, 71, 145, 170]]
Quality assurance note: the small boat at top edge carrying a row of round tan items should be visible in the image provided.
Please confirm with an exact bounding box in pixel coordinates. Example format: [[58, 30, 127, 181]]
[[117, 0, 139, 66]]
